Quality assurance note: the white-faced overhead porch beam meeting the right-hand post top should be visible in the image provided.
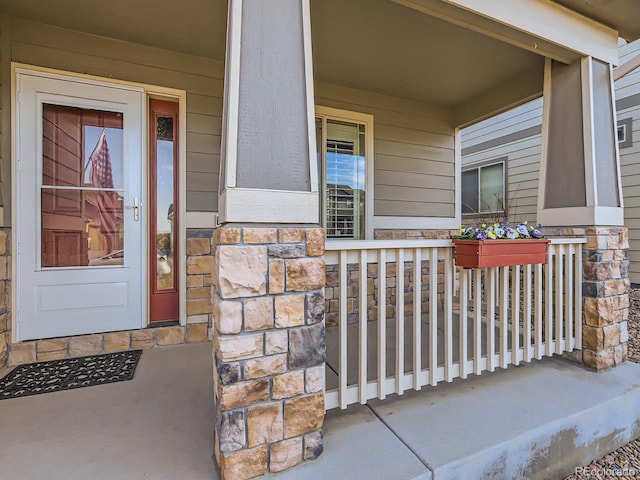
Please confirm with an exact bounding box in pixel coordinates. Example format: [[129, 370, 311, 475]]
[[393, 0, 618, 64]]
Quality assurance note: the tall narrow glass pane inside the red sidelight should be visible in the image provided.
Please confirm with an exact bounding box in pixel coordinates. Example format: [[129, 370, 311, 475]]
[[156, 116, 175, 290]]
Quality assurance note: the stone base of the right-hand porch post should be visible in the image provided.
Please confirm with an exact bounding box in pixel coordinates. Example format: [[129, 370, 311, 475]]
[[582, 227, 630, 371]]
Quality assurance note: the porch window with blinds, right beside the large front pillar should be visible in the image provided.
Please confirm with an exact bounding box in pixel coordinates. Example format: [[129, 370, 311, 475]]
[[316, 108, 371, 239]]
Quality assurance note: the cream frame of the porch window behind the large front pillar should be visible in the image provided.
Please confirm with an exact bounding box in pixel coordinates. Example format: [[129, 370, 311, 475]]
[[314, 105, 374, 242]]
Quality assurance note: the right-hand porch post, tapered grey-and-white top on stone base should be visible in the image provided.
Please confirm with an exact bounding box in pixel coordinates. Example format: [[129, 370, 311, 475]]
[[538, 57, 630, 371]]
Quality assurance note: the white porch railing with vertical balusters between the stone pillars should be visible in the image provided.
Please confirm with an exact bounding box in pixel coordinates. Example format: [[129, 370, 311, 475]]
[[325, 238, 585, 409]]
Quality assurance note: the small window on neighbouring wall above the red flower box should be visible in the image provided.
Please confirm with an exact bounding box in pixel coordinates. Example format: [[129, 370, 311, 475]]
[[462, 161, 506, 214]]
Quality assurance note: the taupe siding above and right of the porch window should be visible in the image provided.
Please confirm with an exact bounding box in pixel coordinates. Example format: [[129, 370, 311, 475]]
[[316, 83, 455, 217]]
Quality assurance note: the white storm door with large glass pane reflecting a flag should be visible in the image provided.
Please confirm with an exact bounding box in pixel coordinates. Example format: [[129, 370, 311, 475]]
[[14, 69, 146, 340]]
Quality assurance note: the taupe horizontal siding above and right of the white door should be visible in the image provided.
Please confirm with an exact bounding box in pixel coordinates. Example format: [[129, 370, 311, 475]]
[[3, 18, 224, 211]]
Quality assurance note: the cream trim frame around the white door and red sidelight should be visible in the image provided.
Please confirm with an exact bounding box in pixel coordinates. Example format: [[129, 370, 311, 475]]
[[10, 62, 187, 343]]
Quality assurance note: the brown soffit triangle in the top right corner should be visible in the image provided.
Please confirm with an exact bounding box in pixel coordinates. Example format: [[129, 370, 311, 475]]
[[554, 0, 640, 42]]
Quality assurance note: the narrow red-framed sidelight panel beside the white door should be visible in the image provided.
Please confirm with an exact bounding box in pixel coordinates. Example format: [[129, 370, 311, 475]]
[[149, 100, 180, 322]]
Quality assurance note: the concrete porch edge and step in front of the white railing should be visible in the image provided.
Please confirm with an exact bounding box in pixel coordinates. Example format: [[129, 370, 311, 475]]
[[274, 358, 640, 480]]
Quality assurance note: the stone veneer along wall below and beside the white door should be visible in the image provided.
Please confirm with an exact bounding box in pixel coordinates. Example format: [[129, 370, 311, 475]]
[[0, 229, 213, 368]]
